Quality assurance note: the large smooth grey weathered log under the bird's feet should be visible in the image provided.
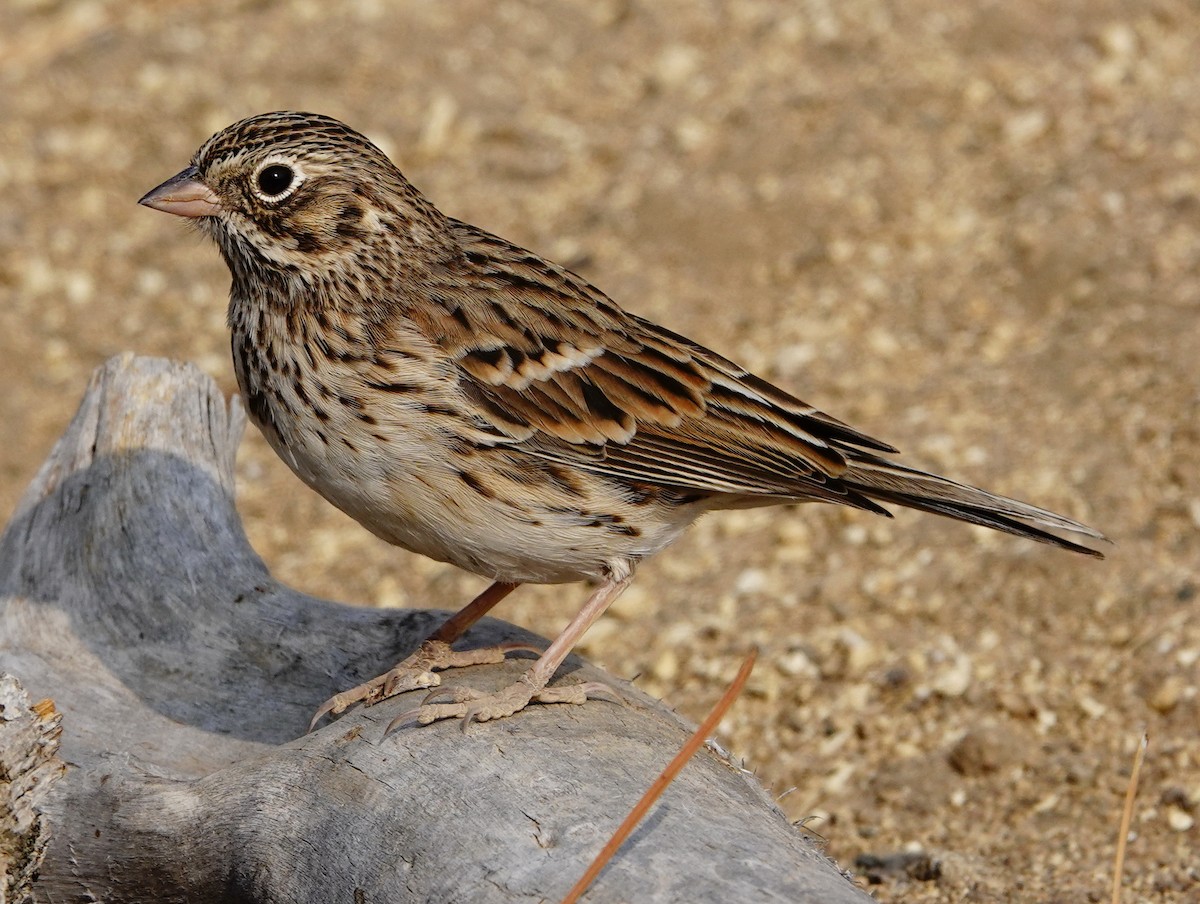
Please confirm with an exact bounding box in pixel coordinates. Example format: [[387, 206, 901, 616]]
[[0, 357, 869, 904]]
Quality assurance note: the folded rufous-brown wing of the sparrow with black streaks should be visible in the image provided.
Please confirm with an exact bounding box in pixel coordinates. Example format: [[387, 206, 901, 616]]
[[412, 223, 890, 501]]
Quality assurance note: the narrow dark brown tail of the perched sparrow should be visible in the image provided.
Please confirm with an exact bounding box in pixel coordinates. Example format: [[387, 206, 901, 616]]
[[840, 455, 1109, 558]]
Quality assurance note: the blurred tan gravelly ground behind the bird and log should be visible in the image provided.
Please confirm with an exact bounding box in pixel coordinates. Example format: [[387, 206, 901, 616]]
[[0, 0, 1200, 902]]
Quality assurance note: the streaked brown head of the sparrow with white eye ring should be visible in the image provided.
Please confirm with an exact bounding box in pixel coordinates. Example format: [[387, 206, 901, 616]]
[[139, 112, 451, 292]]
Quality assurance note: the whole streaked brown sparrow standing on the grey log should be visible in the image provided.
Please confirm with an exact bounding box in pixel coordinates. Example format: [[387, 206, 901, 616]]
[[139, 112, 1108, 731]]
